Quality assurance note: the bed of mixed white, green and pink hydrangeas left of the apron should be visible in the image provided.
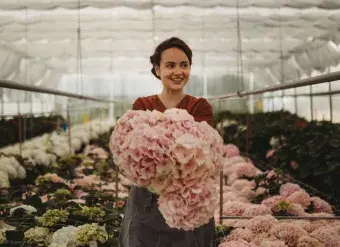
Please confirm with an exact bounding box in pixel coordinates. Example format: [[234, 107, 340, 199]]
[[0, 128, 128, 247]]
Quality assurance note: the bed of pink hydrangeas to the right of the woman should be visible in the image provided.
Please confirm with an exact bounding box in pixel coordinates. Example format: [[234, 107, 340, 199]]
[[215, 146, 340, 247]]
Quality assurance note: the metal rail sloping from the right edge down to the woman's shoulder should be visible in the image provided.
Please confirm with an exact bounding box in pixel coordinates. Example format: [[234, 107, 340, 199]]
[[208, 71, 340, 100]]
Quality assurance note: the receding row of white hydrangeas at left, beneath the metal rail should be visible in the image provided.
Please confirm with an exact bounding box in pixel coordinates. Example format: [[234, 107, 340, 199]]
[[0, 118, 114, 188]]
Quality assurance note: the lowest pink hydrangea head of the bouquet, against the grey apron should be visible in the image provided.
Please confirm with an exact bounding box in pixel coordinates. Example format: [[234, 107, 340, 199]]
[[158, 179, 218, 231]]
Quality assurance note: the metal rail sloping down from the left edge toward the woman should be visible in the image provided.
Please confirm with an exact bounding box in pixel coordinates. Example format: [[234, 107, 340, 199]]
[[0, 79, 117, 103]]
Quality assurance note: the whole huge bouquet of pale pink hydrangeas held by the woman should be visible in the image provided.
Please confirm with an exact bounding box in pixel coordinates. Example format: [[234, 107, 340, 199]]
[[110, 109, 223, 230]]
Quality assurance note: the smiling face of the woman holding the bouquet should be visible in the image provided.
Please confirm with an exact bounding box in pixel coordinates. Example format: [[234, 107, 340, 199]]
[[155, 48, 191, 91]]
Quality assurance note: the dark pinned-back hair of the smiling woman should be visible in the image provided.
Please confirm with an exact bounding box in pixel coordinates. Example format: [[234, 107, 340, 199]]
[[150, 37, 192, 79]]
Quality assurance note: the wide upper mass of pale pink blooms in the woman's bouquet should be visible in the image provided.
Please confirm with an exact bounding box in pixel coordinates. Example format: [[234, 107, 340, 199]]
[[110, 109, 223, 194]]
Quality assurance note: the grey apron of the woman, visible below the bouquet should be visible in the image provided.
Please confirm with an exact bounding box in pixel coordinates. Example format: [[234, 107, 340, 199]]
[[119, 186, 215, 247]]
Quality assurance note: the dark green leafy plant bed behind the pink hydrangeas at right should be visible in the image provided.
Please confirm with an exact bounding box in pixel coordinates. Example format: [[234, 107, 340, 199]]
[[217, 112, 340, 199]]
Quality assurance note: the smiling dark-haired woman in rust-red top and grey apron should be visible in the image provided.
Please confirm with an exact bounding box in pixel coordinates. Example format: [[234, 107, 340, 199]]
[[119, 38, 214, 247]]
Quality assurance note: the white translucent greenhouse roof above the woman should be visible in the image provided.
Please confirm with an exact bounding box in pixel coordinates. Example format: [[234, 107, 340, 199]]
[[0, 0, 340, 99]]
